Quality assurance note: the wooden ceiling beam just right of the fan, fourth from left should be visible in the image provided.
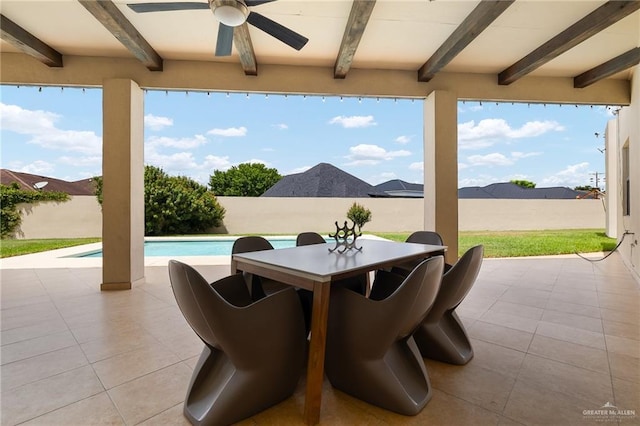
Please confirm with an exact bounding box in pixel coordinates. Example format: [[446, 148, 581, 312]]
[[333, 0, 376, 78]]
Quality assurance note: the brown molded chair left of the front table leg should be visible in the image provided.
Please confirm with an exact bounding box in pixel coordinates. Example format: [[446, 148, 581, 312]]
[[169, 260, 306, 425]]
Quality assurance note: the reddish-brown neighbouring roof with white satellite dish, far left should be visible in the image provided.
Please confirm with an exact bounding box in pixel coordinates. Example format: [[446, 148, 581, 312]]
[[0, 169, 95, 195]]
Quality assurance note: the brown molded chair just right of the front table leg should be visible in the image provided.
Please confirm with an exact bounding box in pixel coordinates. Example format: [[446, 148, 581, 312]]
[[325, 256, 444, 415]]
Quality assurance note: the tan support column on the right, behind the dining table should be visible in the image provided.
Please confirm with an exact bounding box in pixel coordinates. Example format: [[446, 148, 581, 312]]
[[424, 90, 458, 264]]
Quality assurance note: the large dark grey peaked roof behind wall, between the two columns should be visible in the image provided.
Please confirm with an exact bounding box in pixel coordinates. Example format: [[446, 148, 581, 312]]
[[261, 163, 373, 198]]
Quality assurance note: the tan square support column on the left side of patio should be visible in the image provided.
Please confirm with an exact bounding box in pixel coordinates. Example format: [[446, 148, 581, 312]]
[[100, 79, 144, 290]]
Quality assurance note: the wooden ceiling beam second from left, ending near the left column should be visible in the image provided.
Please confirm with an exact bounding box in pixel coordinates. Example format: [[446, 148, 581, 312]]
[[78, 0, 162, 71]]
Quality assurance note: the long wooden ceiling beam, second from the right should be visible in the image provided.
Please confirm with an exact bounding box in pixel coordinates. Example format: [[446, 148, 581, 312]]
[[498, 0, 640, 85]]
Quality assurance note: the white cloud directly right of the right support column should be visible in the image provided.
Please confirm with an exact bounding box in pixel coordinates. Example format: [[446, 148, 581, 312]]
[[458, 118, 564, 149]]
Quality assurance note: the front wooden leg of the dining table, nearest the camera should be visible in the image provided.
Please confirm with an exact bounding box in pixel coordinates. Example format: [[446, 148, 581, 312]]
[[304, 283, 330, 425]]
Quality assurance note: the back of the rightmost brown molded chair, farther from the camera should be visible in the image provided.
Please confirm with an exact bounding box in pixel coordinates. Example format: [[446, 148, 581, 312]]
[[429, 244, 484, 318]]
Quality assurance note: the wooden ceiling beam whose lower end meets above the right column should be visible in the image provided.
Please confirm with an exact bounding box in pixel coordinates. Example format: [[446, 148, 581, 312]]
[[418, 0, 515, 82]]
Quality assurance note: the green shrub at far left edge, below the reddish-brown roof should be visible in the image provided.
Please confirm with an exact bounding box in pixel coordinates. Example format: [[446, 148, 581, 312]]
[[0, 182, 69, 238]]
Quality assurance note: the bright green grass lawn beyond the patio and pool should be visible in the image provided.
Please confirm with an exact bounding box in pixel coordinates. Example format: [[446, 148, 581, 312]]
[[0, 229, 616, 258]]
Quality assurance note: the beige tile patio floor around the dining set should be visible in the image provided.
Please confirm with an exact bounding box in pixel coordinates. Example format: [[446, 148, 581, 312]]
[[0, 253, 640, 425]]
